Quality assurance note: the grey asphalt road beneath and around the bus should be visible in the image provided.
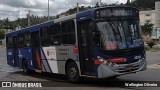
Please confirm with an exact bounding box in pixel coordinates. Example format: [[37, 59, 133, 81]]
[[0, 48, 160, 90]]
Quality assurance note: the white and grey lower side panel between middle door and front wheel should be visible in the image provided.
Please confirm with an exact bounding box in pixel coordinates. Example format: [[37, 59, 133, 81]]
[[41, 46, 80, 74]]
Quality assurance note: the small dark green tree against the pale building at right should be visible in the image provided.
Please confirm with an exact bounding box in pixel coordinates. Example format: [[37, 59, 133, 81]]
[[141, 22, 153, 35]]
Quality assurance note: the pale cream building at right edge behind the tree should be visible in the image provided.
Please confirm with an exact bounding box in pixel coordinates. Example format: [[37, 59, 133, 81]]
[[139, 1, 160, 39]]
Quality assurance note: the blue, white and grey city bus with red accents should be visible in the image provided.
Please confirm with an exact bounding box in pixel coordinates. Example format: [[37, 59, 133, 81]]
[[6, 6, 146, 82]]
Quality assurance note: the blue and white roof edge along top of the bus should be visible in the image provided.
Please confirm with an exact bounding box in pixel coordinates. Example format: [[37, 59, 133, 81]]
[[6, 6, 137, 36]]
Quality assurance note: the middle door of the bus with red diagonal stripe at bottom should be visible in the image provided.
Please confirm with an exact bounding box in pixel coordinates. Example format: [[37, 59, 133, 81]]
[[31, 31, 41, 70]]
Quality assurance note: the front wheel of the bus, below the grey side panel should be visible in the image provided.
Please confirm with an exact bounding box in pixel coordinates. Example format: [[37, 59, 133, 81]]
[[66, 62, 80, 83]]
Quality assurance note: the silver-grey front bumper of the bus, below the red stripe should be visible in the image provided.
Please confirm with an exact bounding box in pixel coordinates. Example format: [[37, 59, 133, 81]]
[[98, 59, 147, 78]]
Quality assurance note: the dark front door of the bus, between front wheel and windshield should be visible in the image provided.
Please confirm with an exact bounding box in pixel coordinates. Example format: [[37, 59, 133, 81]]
[[78, 21, 94, 75]]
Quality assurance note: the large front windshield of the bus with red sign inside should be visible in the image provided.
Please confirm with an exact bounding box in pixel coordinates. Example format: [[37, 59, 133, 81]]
[[96, 20, 143, 50]]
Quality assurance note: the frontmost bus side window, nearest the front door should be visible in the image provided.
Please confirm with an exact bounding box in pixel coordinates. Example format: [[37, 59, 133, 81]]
[[62, 20, 75, 45]]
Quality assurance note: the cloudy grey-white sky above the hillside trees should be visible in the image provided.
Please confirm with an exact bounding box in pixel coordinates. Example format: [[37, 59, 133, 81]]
[[0, 0, 127, 20]]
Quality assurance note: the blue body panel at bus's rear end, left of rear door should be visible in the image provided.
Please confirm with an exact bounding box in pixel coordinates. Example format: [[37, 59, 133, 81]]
[[7, 49, 14, 66]]
